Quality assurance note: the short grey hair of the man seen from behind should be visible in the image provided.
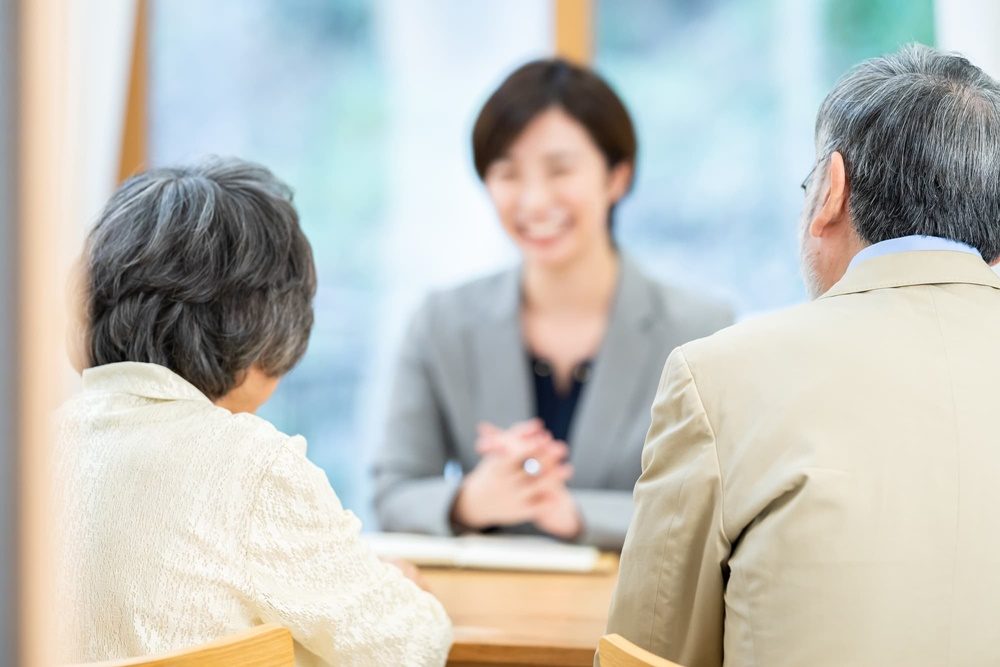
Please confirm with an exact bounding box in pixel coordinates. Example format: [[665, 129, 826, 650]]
[[816, 44, 1000, 262]]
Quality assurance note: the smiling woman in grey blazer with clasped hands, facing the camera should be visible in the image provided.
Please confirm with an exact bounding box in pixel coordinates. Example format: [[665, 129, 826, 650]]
[[376, 59, 730, 549]]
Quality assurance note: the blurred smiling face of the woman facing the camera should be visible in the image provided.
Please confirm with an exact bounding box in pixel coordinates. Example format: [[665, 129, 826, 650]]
[[485, 107, 631, 266]]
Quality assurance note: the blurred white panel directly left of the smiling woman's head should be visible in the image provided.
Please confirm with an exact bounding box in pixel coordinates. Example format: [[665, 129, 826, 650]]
[[360, 0, 555, 518]]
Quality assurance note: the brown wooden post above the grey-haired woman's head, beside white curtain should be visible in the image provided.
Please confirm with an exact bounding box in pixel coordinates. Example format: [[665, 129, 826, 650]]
[[118, 0, 149, 183]]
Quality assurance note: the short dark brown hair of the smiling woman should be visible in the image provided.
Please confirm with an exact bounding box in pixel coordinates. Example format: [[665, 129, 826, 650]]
[[472, 58, 637, 185]]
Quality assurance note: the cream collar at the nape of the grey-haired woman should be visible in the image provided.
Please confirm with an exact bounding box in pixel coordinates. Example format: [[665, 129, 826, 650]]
[[83, 361, 210, 402]]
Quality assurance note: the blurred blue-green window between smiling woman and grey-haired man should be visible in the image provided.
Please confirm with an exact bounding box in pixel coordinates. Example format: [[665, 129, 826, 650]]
[[596, 0, 933, 315]]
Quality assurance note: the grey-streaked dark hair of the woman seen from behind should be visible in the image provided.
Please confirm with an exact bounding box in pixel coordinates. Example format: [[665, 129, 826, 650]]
[[83, 158, 316, 400]]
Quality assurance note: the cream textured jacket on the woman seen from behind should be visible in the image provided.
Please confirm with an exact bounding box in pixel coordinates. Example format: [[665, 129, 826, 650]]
[[54, 363, 451, 665]]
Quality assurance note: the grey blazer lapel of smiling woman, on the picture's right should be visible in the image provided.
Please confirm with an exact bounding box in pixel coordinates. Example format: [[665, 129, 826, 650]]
[[569, 257, 656, 487]]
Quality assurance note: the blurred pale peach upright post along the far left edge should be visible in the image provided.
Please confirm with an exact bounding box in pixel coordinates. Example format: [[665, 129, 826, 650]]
[[14, 0, 73, 666]]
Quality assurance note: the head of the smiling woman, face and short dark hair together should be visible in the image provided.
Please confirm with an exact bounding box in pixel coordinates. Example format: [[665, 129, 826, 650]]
[[472, 60, 636, 272]]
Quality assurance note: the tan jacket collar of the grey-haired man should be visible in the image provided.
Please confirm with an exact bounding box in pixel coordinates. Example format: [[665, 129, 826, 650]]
[[820, 250, 1000, 299]]
